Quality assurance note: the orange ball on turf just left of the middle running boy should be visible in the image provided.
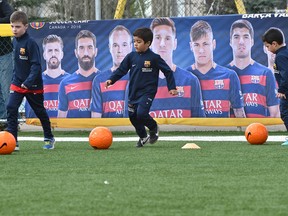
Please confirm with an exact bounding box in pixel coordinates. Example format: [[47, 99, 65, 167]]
[[89, 127, 113, 149]]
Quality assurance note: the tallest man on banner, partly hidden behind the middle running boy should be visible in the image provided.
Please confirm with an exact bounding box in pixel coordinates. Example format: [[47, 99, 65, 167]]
[[150, 17, 205, 118]]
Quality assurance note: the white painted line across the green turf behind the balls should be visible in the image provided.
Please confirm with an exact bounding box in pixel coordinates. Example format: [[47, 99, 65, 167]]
[[18, 136, 286, 142]]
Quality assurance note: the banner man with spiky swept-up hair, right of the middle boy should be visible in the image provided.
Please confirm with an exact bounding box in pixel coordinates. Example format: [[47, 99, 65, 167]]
[[187, 20, 246, 118]]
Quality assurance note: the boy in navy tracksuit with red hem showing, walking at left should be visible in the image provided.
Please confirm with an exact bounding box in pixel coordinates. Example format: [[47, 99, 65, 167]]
[[7, 11, 56, 151]]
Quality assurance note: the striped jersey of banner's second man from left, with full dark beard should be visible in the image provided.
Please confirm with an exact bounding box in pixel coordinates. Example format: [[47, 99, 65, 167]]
[[59, 71, 100, 118]]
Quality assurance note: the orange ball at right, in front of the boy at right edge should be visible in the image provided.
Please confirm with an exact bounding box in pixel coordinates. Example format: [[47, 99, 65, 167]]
[[245, 123, 268, 145]]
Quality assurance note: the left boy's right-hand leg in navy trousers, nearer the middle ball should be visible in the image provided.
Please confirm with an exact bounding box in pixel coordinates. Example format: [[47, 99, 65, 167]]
[[26, 94, 54, 139]]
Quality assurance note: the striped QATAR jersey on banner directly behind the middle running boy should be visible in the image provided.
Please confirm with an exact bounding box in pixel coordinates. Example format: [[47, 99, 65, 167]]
[[150, 67, 205, 118]]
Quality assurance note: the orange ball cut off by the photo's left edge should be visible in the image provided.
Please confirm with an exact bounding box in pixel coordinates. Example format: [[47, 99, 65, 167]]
[[0, 131, 16, 155]]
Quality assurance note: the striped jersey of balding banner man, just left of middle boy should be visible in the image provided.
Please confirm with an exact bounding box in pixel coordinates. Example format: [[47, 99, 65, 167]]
[[91, 70, 129, 118]]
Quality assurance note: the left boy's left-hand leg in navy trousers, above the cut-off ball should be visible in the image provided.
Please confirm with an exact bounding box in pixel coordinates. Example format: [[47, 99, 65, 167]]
[[7, 92, 25, 141]]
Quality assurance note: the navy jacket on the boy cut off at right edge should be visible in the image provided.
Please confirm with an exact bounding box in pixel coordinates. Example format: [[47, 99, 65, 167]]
[[274, 46, 288, 97]]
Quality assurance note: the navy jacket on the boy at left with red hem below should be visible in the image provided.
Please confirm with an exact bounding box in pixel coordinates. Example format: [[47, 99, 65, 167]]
[[12, 32, 43, 90]]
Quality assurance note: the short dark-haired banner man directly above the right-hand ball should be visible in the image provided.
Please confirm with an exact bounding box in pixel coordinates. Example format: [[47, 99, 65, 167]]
[[227, 19, 280, 118]]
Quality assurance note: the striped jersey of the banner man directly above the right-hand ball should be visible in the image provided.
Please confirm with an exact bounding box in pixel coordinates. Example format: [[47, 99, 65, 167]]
[[228, 61, 279, 118]]
